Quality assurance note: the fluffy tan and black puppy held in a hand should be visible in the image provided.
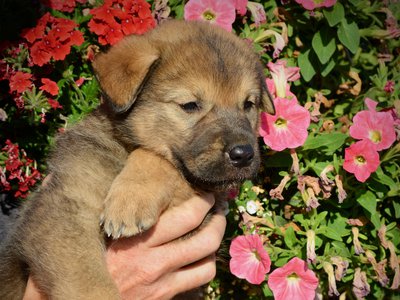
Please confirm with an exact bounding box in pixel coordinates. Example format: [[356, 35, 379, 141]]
[[0, 21, 274, 300]]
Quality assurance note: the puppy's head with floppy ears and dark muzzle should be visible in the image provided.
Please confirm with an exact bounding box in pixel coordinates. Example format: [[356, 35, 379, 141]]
[[94, 21, 274, 190]]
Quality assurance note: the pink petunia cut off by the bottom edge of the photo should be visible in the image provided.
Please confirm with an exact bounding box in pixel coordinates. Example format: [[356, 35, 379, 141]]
[[268, 257, 318, 300]]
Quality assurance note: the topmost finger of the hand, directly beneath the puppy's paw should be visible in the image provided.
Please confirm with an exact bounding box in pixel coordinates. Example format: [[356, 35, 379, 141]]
[[141, 193, 215, 247]]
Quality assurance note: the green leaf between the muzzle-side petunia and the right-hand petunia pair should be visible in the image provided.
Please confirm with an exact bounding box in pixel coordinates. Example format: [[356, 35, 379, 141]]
[[303, 132, 348, 152]]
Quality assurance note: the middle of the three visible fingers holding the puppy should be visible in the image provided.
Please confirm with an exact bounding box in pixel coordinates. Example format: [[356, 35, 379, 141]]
[[153, 212, 226, 273]]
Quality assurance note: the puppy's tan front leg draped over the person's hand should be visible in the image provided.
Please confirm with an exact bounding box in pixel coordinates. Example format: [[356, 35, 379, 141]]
[[101, 149, 183, 239]]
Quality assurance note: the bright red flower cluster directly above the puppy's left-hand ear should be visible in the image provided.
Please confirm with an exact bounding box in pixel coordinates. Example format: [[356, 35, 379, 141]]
[[88, 0, 156, 45]]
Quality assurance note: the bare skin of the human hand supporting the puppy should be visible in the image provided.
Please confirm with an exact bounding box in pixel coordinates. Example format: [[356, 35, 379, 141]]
[[24, 194, 226, 300]]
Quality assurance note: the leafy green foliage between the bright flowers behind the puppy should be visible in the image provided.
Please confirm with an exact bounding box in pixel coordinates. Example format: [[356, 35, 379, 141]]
[[0, 0, 400, 299]]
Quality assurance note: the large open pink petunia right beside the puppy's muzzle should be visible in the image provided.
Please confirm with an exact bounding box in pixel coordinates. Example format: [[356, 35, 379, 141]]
[[260, 98, 310, 151]]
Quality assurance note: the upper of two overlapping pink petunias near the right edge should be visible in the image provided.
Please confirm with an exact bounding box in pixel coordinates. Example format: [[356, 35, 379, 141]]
[[349, 98, 396, 151]]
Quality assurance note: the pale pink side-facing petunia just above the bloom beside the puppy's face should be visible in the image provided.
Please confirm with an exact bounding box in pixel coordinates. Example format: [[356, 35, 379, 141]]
[[267, 59, 300, 98]]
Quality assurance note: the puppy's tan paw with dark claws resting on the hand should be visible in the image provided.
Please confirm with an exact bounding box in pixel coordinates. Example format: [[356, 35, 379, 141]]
[[100, 182, 160, 239]]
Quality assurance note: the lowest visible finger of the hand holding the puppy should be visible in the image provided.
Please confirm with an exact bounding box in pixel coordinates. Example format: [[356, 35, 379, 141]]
[[165, 255, 216, 299]]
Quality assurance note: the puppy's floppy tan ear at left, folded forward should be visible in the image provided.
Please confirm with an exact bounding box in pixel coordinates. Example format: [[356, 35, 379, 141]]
[[93, 36, 160, 113]]
